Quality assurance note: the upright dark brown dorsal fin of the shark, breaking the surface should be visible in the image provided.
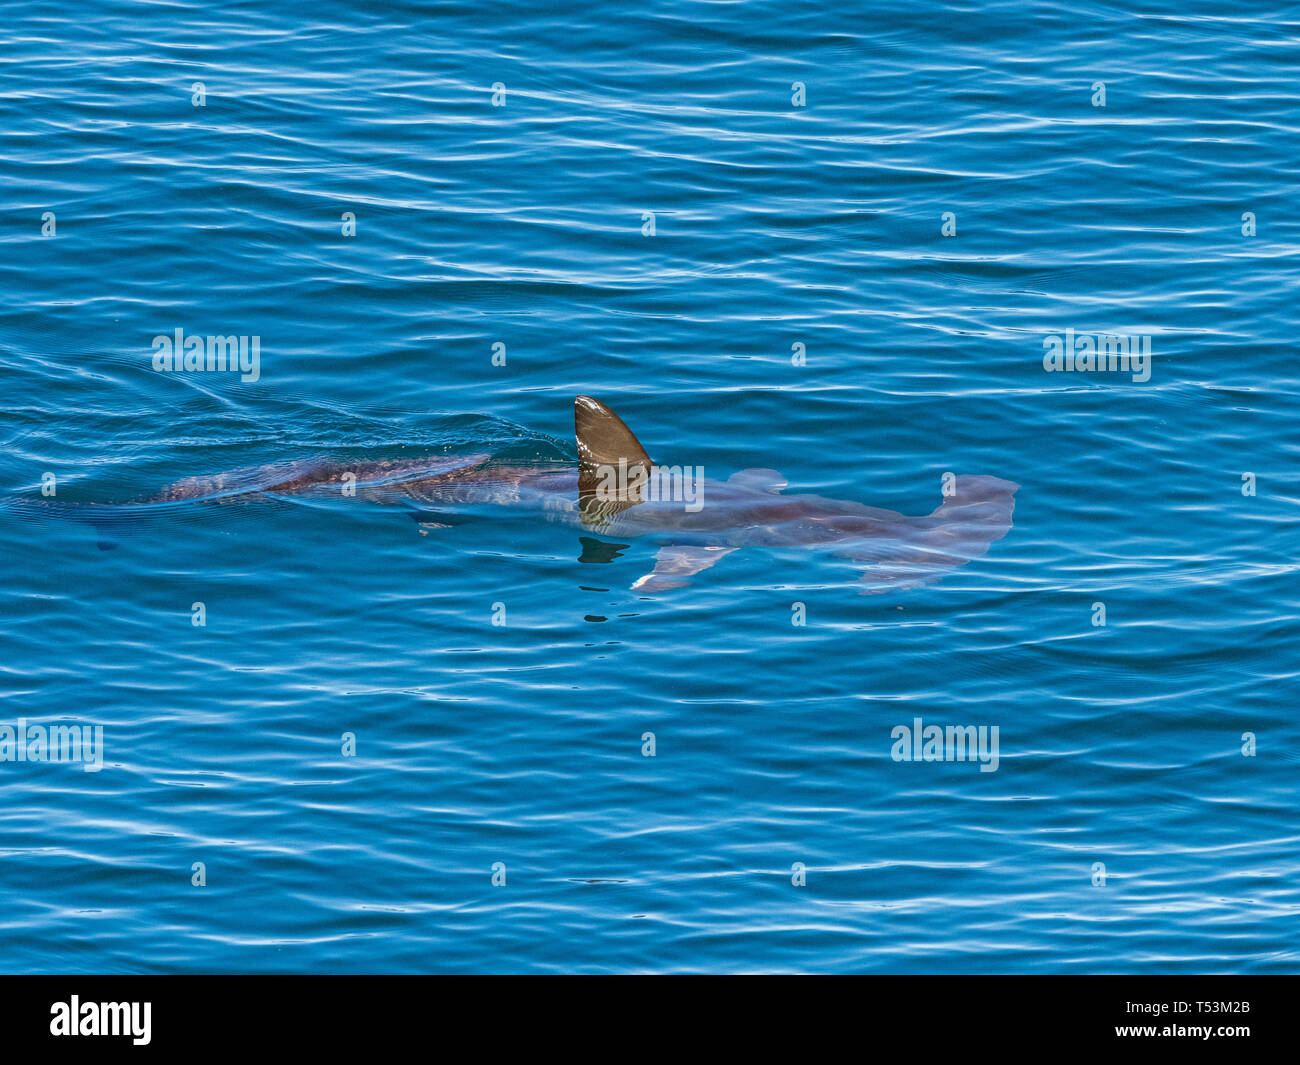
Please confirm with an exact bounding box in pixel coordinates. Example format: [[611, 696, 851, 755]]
[[573, 395, 650, 525]]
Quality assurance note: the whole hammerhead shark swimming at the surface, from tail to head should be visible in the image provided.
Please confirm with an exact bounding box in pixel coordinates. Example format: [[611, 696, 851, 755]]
[[22, 395, 1019, 593]]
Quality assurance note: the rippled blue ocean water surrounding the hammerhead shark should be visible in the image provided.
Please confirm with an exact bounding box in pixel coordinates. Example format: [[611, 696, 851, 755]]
[[0, 0, 1300, 973]]
